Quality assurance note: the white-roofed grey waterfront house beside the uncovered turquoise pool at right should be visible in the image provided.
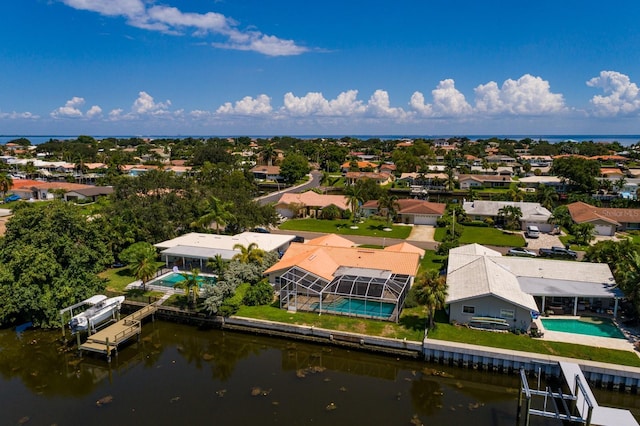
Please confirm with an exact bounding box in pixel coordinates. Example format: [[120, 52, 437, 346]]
[[446, 244, 624, 330]]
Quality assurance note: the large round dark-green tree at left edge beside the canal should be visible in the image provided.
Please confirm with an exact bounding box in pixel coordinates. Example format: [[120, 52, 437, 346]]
[[0, 201, 113, 327]]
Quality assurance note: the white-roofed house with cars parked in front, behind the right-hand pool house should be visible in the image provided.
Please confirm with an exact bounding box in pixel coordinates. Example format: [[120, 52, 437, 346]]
[[462, 200, 553, 232]]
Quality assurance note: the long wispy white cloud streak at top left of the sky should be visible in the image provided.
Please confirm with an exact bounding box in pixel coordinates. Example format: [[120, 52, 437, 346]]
[[61, 0, 309, 56]]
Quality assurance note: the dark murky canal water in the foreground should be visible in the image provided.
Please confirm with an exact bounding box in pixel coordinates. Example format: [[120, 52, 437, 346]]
[[0, 321, 640, 426]]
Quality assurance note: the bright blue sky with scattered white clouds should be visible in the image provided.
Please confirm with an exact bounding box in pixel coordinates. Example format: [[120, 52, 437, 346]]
[[0, 0, 640, 135]]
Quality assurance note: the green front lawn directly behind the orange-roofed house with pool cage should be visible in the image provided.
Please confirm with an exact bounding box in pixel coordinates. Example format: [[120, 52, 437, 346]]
[[280, 219, 412, 239]]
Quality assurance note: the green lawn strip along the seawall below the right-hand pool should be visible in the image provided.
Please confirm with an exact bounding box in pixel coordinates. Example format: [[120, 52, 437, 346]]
[[429, 322, 640, 367]]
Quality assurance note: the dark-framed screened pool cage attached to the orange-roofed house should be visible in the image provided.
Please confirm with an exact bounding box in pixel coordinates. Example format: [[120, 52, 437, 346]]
[[280, 267, 412, 322]]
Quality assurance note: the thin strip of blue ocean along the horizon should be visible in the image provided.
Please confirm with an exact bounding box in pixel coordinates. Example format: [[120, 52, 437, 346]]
[[0, 134, 640, 146]]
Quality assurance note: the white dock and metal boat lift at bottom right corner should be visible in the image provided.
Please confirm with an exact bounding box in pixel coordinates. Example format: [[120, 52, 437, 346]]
[[516, 362, 638, 426]]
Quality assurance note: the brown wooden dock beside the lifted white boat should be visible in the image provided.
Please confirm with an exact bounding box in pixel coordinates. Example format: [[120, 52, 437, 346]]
[[78, 304, 158, 362]]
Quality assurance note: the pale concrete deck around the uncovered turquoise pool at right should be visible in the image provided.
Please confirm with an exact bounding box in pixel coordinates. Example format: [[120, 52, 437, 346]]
[[535, 316, 640, 356]]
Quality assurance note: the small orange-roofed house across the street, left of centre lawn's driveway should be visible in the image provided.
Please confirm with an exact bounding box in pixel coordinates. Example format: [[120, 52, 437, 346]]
[[275, 191, 349, 218]]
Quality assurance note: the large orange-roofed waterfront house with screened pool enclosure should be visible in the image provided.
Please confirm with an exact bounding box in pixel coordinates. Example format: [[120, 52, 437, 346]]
[[264, 236, 420, 321]]
